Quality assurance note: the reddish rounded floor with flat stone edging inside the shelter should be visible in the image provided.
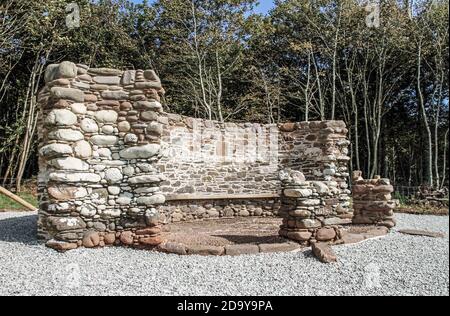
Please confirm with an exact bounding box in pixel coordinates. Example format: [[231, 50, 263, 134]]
[[158, 217, 389, 256]]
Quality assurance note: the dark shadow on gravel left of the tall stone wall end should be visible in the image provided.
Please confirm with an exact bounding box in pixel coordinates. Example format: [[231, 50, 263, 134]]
[[0, 215, 40, 245]]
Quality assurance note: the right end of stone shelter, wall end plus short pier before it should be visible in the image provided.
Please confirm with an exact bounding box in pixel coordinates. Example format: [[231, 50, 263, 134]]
[[279, 122, 353, 244]]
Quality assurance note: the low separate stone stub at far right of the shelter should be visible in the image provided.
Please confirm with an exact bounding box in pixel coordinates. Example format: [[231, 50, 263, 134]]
[[352, 171, 397, 228]]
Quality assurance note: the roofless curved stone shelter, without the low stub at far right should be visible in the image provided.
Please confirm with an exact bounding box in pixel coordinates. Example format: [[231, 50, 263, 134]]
[[38, 62, 384, 251]]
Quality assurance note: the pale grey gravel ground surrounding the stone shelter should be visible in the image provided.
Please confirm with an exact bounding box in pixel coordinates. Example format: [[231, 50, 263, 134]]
[[0, 213, 449, 296]]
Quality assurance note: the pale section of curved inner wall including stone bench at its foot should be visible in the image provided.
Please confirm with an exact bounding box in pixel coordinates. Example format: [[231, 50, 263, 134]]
[[158, 114, 279, 221]]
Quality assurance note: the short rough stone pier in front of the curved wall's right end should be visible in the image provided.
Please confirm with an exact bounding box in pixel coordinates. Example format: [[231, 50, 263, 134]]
[[280, 169, 351, 245]]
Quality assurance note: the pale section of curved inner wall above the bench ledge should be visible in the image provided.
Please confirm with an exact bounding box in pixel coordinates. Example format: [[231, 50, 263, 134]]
[[158, 114, 278, 196]]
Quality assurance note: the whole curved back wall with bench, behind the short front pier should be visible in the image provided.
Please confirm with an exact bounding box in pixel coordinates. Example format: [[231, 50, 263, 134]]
[[155, 118, 350, 221]]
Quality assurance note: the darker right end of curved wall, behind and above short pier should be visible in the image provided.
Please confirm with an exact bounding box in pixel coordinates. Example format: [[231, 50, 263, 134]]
[[280, 121, 353, 219]]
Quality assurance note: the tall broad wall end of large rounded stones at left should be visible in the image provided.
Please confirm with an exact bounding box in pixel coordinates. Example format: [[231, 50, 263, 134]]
[[38, 62, 165, 250]]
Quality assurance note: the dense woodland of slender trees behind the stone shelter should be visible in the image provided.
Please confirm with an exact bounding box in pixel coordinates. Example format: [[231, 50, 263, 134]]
[[0, 0, 449, 191]]
